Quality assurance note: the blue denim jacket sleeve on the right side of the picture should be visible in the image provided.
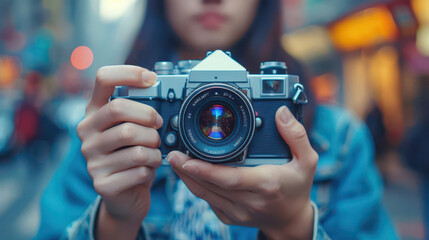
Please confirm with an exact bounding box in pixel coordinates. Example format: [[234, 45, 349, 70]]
[[320, 119, 397, 239]]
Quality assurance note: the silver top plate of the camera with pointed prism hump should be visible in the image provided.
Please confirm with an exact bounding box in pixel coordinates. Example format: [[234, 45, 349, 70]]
[[122, 50, 299, 100]]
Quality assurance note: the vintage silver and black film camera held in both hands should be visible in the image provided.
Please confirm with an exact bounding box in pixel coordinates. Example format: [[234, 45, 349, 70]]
[[111, 50, 307, 166]]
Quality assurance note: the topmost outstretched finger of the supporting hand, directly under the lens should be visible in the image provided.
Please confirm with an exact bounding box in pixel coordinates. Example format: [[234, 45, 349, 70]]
[[167, 151, 267, 190]]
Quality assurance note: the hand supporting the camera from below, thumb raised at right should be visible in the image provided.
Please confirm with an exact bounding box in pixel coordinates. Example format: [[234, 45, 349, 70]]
[[167, 107, 318, 239]]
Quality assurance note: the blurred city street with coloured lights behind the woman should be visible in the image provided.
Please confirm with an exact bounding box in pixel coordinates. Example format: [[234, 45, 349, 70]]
[[0, 0, 429, 239]]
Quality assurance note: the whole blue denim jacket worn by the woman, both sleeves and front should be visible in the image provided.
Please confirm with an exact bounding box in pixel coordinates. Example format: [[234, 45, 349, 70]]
[[35, 106, 397, 240]]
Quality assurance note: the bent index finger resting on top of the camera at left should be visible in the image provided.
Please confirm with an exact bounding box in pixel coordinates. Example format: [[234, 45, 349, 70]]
[[87, 65, 156, 115]]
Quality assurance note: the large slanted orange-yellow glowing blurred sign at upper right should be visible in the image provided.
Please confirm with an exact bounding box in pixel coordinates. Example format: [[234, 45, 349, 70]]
[[329, 7, 399, 51]]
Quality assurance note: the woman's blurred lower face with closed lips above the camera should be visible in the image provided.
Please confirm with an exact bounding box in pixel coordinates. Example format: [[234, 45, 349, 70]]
[[165, 0, 260, 51]]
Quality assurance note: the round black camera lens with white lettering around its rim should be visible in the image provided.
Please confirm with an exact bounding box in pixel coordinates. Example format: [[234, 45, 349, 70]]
[[179, 83, 255, 162]]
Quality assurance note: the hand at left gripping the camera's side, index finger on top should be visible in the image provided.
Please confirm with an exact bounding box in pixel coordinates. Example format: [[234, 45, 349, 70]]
[[77, 66, 163, 239]]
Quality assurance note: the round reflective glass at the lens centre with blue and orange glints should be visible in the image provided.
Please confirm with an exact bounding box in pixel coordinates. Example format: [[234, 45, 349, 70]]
[[199, 104, 235, 140]]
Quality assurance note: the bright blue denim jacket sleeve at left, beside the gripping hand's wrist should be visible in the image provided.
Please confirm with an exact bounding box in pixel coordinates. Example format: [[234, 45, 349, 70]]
[[34, 131, 97, 239]]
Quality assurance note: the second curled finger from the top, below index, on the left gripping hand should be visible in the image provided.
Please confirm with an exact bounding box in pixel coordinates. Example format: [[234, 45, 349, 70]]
[[89, 123, 161, 154]]
